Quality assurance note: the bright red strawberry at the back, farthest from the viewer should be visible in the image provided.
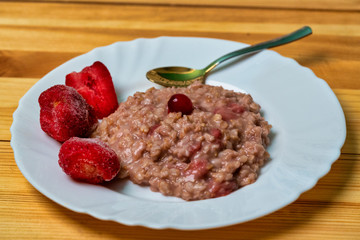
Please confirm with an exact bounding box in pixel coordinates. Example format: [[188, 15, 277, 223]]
[[66, 61, 119, 119]]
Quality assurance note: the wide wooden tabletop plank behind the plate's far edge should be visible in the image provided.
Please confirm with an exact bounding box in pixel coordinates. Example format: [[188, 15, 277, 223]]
[[0, 2, 360, 89]]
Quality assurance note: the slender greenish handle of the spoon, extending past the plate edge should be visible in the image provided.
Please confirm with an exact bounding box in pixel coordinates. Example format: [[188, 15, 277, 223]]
[[203, 26, 312, 73]]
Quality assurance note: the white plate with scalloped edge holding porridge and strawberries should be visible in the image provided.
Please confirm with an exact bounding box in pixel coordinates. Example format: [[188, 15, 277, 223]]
[[11, 37, 346, 229]]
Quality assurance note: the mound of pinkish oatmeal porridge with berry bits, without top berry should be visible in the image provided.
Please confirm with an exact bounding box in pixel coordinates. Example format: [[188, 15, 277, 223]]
[[92, 83, 271, 200]]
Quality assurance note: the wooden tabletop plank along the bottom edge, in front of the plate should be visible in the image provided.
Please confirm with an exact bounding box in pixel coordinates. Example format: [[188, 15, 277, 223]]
[[0, 202, 359, 240]]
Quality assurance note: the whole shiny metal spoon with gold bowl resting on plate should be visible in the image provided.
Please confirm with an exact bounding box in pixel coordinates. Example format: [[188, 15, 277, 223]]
[[146, 26, 312, 87]]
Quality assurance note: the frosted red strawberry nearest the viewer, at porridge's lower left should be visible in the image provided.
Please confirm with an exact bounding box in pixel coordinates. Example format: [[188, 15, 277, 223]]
[[59, 137, 120, 184]]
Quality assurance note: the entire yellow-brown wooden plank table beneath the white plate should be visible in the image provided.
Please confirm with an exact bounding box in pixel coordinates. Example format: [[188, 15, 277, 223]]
[[0, 0, 360, 240]]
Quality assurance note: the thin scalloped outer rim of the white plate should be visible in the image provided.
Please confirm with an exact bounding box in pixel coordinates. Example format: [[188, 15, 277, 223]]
[[10, 36, 346, 230]]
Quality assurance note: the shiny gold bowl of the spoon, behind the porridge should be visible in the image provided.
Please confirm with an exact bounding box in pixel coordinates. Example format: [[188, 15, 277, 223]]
[[146, 66, 205, 87]]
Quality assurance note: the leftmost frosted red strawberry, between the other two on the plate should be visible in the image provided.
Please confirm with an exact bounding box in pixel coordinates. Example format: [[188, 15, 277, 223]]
[[38, 85, 98, 142]]
